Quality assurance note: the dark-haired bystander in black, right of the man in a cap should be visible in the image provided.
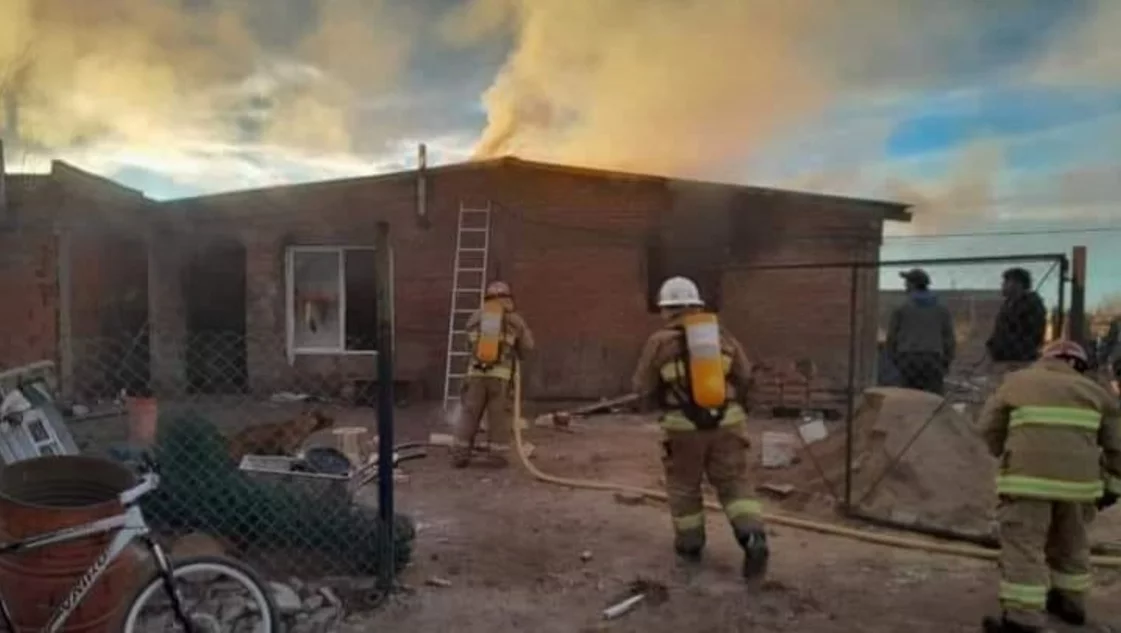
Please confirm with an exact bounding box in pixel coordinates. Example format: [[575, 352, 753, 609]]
[[985, 268, 1047, 364]]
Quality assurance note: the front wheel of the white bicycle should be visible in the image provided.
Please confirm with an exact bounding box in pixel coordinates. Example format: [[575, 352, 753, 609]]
[[122, 556, 280, 633]]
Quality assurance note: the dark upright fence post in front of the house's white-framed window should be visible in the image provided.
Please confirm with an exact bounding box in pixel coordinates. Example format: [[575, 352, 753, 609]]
[[374, 222, 397, 595]]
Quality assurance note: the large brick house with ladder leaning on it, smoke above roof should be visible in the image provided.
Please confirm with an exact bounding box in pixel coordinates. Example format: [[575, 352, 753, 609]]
[[150, 158, 910, 399]]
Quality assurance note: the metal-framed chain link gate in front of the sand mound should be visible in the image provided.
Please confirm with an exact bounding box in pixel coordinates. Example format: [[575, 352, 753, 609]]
[[847, 255, 1066, 542]]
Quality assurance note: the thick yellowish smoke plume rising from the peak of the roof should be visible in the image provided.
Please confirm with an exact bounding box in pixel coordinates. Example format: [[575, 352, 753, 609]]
[[445, 0, 1118, 176]]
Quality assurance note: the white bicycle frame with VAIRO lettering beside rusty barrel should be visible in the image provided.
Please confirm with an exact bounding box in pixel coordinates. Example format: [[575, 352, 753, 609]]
[[0, 476, 170, 633]]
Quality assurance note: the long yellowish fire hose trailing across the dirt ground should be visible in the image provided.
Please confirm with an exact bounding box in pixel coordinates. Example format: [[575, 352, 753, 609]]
[[513, 367, 1121, 568]]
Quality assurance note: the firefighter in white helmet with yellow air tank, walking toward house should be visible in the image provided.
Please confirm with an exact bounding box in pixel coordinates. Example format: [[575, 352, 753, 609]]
[[633, 277, 769, 579]]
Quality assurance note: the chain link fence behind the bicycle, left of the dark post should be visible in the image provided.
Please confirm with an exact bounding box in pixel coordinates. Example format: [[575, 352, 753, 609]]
[[62, 327, 415, 578]]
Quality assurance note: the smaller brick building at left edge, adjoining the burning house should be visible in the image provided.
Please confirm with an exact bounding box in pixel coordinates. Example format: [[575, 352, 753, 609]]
[[0, 156, 150, 394]]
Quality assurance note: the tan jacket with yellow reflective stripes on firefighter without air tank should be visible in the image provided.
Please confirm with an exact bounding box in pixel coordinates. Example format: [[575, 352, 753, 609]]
[[981, 359, 1121, 503]]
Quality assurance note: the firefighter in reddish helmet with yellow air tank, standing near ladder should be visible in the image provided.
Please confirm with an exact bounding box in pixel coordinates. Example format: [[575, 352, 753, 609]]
[[452, 281, 534, 468]]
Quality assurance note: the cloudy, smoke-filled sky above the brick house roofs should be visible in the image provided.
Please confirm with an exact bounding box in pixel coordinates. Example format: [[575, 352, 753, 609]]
[[0, 0, 1121, 300]]
